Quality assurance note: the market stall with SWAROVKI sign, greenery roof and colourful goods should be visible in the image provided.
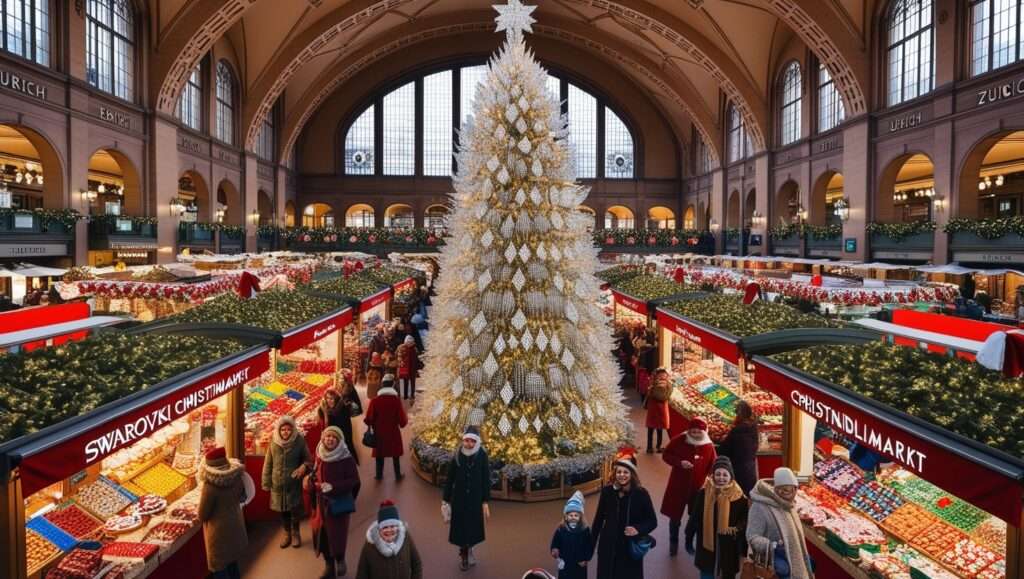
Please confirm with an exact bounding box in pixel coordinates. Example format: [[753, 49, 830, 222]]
[[0, 332, 269, 579]]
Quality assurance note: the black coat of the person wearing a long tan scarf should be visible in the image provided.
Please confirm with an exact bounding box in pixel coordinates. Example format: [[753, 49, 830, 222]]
[[685, 483, 748, 578]]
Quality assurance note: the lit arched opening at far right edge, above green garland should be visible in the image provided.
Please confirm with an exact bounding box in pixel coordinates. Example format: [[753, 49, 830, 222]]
[[950, 129, 1024, 218]]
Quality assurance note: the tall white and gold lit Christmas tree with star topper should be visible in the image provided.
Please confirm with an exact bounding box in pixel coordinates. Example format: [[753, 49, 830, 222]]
[[414, 0, 632, 477]]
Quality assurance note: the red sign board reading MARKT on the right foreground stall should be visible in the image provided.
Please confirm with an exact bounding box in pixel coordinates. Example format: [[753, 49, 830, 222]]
[[754, 356, 1024, 527]]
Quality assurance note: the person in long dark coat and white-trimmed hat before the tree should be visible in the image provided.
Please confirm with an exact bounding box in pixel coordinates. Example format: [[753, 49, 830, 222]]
[[441, 425, 490, 571]]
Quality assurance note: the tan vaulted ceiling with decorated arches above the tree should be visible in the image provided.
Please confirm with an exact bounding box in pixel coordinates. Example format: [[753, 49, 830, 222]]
[[150, 0, 877, 162]]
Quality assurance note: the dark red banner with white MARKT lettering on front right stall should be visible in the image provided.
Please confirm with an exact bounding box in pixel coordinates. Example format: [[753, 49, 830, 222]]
[[755, 364, 1022, 527]]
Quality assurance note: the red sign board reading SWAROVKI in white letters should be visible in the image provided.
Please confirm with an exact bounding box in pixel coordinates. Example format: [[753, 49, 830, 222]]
[[18, 350, 270, 497]]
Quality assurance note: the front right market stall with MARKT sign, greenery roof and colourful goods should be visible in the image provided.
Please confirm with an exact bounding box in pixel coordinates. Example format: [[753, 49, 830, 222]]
[[753, 336, 1024, 579]]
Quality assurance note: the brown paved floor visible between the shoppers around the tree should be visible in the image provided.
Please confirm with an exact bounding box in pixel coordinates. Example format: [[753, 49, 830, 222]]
[[243, 383, 697, 579]]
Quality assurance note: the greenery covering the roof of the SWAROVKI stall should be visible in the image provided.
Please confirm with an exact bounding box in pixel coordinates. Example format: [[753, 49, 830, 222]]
[[0, 332, 243, 442]]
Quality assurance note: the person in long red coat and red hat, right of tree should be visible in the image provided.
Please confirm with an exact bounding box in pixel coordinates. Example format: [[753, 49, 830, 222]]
[[662, 418, 718, 556]]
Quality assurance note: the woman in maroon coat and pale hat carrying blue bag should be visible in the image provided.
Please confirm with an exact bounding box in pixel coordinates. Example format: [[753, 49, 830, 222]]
[[307, 426, 359, 579]]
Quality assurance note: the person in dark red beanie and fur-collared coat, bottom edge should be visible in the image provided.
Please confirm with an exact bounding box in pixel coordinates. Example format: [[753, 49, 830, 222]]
[[355, 500, 423, 579]]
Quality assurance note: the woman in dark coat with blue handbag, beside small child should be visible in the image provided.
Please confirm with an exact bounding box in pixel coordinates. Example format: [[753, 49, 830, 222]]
[[591, 453, 657, 579]]
